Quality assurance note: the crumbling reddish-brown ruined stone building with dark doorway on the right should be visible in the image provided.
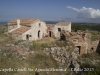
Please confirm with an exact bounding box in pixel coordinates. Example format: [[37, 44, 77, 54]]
[[61, 30, 98, 55]]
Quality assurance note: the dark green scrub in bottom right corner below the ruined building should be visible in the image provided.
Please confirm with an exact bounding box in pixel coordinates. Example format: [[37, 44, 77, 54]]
[[81, 52, 100, 75]]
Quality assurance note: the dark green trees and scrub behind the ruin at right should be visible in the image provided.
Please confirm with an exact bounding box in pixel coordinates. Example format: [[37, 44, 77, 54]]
[[72, 23, 100, 41]]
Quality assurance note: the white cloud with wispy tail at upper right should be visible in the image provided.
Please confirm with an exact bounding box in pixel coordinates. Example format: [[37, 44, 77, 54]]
[[67, 6, 100, 18]]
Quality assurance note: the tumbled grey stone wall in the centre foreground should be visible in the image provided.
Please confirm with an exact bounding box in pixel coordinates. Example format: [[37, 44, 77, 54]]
[[43, 46, 79, 67]]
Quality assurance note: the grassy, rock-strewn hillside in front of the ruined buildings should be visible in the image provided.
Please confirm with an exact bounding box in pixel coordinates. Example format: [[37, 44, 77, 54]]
[[0, 24, 100, 75]]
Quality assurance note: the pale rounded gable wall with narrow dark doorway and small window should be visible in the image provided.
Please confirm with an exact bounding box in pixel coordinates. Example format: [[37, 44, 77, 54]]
[[31, 21, 47, 40]]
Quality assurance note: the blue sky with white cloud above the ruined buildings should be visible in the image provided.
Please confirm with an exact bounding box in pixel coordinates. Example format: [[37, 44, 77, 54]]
[[0, 0, 100, 23]]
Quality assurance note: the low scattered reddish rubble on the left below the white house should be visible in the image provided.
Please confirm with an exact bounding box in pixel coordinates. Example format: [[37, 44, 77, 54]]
[[0, 41, 32, 55]]
